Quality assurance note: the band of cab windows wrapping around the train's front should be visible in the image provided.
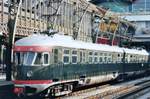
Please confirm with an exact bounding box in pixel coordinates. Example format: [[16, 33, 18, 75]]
[[14, 52, 49, 66]]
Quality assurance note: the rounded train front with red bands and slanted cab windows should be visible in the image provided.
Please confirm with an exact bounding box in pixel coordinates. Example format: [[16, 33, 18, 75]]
[[13, 37, 52, 95]]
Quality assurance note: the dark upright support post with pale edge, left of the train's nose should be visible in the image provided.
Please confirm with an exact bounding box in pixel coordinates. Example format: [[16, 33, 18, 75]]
[[6, 0, 22, 81]]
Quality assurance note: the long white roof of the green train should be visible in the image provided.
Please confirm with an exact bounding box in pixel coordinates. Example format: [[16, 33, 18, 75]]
[[15, 34, 148, 55]]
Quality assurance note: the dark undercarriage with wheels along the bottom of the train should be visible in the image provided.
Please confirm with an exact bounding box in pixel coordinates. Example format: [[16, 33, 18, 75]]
[[13, 70, 150, 97]]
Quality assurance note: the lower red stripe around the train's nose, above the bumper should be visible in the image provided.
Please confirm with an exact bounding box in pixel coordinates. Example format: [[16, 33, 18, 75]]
[[13, 80, 53, 84]]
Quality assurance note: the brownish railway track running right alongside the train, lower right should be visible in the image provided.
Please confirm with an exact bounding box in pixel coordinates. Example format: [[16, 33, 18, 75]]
[[59, 77, 150, 99]]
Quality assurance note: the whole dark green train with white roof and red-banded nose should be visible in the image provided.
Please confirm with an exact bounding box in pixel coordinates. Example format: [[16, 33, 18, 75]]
[[13, 33, 150, 97]]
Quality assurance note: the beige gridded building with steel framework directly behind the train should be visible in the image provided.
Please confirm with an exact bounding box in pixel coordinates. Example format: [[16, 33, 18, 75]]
[[0, 0, 134, 67]]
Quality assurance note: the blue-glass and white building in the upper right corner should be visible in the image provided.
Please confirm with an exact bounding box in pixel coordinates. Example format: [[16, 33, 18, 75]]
[[91, 0, 150, 50]]
